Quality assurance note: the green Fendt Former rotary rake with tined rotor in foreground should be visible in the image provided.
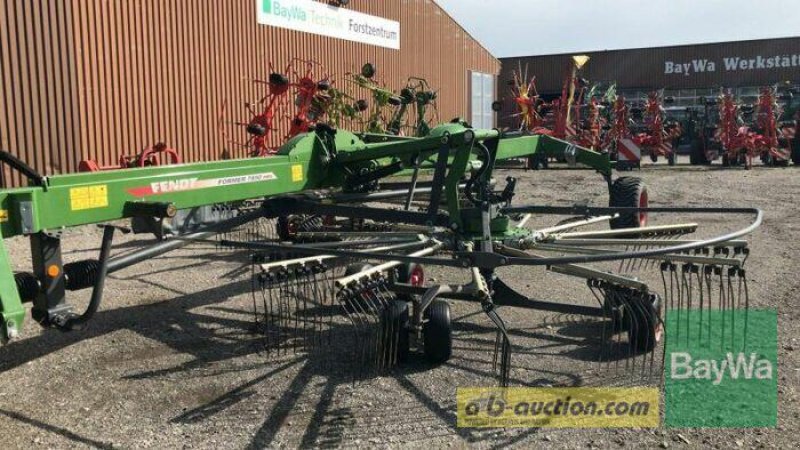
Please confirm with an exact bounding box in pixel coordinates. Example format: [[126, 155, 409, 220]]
[[0, 123, 761, 385]]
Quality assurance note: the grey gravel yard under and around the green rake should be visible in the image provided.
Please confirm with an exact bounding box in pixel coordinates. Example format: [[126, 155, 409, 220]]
[[0, 156, 800, 448]]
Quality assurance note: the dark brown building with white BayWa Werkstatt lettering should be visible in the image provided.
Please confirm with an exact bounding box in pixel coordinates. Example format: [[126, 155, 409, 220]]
[[499, 37, 800, 125]]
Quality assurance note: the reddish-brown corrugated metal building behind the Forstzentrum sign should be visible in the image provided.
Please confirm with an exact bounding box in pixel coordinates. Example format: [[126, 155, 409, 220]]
[[0, 0, 500, 187]]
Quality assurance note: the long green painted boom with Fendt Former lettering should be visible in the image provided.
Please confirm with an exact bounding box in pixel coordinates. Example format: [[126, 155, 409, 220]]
[[0, 124, 612, 337]]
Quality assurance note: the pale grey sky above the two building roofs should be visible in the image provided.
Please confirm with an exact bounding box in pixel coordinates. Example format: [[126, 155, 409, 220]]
[[435, 0, 800, 57]]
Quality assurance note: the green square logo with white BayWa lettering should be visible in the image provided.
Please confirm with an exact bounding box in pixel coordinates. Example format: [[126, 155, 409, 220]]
[[665, 309, 778, 428]]
